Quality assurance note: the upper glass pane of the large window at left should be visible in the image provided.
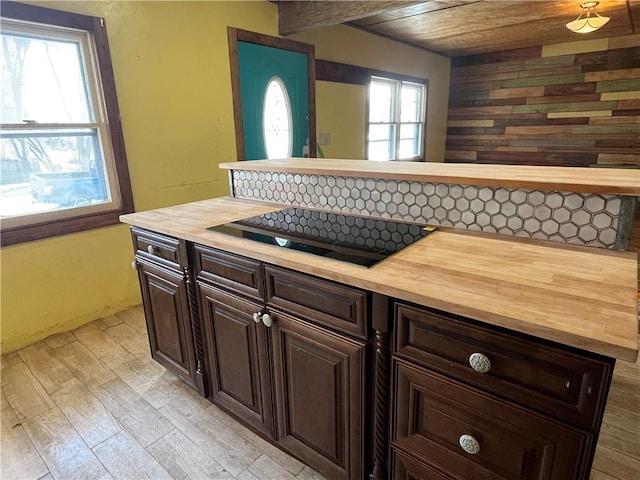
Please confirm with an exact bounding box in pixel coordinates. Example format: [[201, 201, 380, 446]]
[[0, 33, 93, 123]]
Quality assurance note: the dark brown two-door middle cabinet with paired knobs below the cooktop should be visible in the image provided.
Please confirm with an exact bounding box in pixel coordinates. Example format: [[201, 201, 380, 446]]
[[194, 245, 367, 479]]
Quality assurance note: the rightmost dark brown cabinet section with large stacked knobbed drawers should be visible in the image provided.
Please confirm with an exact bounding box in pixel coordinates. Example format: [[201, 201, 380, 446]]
[[391, 302, 613, 480]]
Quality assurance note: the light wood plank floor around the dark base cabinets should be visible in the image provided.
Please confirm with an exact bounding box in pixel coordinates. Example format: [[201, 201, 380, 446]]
[[0, 307, 640, 480]]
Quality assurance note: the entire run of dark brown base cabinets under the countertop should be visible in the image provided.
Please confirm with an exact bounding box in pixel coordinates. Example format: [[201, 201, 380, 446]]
[[132, 228, 614, 480]]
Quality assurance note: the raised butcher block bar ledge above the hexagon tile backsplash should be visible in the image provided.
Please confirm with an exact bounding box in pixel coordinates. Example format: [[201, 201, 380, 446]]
[[220, 158, 640, 196]]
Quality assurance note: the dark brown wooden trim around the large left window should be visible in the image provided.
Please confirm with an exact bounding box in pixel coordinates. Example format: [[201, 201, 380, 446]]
[[0, 1, 134, 246]]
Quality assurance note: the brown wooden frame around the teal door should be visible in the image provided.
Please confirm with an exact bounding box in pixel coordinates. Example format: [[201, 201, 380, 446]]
[[227, 27, 316, 161]]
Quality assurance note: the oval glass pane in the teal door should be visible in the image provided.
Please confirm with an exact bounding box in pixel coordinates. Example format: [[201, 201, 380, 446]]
[[262, 77, 293, 159]]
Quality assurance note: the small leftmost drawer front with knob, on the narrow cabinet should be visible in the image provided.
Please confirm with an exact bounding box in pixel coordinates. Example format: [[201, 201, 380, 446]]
[[131, 228, 188, 271]]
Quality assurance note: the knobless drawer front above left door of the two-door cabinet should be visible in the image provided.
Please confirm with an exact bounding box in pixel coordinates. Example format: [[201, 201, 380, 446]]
[[194, 245, 264, 302]]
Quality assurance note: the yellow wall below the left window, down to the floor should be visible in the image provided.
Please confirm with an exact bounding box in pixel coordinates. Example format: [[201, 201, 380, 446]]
[[2, 226, 140, 353]]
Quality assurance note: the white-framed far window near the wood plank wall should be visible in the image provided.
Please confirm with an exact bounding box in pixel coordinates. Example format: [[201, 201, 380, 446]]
[[367, 76, 426, 161]]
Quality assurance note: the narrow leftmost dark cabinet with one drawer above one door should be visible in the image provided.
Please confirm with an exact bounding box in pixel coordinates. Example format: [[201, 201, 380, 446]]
[[132, 230, 198, 388]]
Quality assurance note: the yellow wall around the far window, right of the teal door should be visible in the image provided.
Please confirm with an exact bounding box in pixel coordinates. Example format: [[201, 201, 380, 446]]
[[291, 25, 451, 162]]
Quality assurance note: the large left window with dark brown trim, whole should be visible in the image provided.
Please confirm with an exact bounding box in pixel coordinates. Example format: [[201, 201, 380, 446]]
[[0, 2, 133, 245]]
